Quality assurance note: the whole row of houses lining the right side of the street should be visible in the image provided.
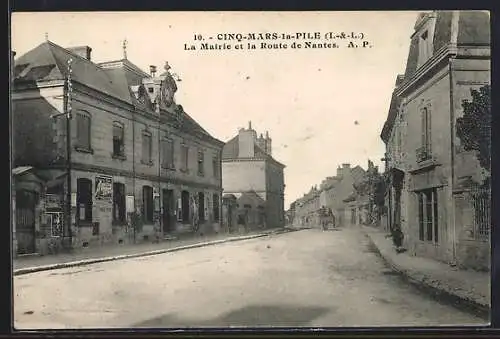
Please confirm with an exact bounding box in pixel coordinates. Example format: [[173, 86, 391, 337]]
[[287, 11, 491, 270]]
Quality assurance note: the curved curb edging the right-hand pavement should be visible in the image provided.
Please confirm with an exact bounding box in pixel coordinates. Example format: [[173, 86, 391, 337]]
[[363, 230, 491, 321]]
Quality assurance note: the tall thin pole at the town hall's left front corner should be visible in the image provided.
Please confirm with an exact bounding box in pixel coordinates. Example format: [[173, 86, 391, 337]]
[[50, 58, 73, 248]]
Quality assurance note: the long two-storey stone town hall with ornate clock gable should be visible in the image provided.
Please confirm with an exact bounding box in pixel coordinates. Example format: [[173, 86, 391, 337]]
[[12, 41, 223, 252]]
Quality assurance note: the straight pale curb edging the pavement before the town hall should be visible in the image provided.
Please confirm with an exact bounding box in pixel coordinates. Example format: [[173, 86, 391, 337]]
[[13, 234, 286, 276]]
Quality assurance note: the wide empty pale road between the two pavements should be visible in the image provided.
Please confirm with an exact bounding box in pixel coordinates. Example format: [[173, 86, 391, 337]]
[[14, 228, 484, 329]]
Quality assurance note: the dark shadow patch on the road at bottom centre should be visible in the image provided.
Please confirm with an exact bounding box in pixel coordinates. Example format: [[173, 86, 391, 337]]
[[132, 305, 330, 328]]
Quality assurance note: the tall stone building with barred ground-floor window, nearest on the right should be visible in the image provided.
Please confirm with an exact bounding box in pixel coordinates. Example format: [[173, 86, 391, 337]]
[[381, 11, 491, 268]]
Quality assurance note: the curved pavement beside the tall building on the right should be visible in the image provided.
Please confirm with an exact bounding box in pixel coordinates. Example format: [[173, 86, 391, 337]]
[[362, 226, 491, 316]]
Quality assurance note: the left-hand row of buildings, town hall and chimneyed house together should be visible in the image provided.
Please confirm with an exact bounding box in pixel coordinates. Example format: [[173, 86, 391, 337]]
[[11, 41, 284, 254]]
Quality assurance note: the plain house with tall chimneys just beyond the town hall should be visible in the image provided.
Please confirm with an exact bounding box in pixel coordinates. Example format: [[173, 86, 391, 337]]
[[222, 122, 285, 231]]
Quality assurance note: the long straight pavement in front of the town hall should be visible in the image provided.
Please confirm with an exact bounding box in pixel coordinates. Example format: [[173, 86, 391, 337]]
[[13, 228, 291, 275]]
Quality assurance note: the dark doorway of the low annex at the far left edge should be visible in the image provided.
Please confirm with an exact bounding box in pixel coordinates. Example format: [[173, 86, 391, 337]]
[[16, 190, 38, 254]]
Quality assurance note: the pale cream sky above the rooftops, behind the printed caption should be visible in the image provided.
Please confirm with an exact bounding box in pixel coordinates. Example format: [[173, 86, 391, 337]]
[[11, 11, 418, 208]]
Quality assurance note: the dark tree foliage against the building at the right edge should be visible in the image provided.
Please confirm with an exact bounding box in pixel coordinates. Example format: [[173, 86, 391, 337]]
[[456, 85, 491, 171]]
